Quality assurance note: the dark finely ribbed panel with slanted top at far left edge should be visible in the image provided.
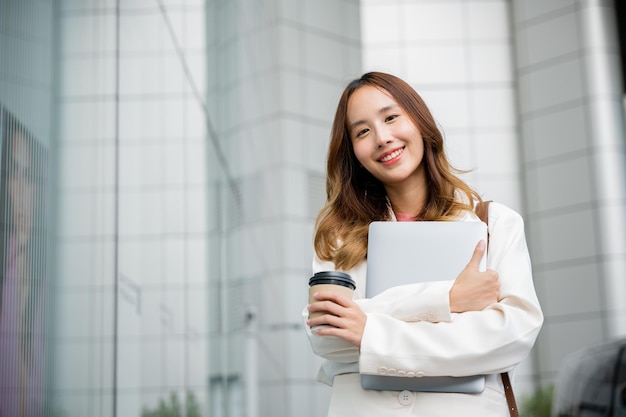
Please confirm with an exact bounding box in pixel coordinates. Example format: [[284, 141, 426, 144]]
[[0, 110, 45, 417]]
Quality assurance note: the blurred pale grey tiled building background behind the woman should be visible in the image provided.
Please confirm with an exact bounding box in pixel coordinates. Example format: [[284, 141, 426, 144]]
[[0, 0, 626, 417]]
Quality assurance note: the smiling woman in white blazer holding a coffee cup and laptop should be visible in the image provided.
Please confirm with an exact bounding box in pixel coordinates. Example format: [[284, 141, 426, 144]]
[[303, 73, 543, 417]]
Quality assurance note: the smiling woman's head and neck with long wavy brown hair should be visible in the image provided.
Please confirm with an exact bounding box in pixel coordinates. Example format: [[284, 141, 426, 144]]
[[315, 73, 480, 268]]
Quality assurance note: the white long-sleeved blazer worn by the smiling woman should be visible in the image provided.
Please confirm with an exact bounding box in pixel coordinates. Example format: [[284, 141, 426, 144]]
[[302, 202, 543, 417]]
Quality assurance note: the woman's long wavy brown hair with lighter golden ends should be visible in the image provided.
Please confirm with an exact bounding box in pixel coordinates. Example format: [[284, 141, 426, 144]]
[[314, 72, 481, 270]]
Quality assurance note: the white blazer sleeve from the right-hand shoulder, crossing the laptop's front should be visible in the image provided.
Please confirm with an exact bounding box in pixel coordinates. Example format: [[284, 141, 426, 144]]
[[359, 203, 543, 376]]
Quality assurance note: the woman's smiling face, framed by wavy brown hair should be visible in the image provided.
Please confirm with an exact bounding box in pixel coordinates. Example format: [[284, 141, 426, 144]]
[[347, 86, 426, 189]]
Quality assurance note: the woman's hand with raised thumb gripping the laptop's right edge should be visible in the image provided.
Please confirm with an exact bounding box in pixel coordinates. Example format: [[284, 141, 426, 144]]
[[450, 240, 500, 313]]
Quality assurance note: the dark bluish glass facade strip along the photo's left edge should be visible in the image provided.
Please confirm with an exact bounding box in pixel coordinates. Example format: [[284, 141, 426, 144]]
[[0, 1, 55, 417]]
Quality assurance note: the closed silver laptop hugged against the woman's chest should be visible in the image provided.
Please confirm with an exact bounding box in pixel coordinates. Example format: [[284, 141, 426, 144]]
[[361, 222, 487, 394]]
